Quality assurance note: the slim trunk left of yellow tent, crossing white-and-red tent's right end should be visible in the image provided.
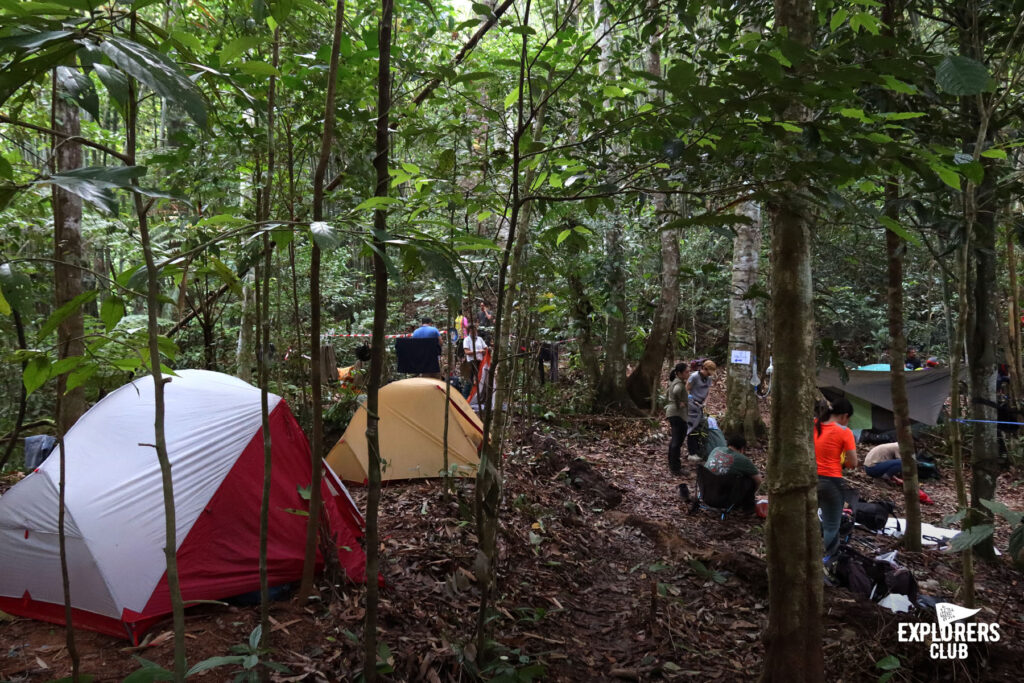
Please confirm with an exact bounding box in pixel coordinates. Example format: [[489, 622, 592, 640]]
[[299, 0, 346, 598]]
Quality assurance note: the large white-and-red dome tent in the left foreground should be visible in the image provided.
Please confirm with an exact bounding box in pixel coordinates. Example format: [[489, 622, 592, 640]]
[[0, 370, 366, 643]]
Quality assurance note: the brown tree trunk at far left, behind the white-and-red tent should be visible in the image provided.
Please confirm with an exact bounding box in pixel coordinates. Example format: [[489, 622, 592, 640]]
[[50, 74, 87, 433]]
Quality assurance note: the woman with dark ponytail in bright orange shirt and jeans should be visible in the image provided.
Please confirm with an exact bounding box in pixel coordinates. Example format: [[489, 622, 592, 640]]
[[814, 398, 857, 558]]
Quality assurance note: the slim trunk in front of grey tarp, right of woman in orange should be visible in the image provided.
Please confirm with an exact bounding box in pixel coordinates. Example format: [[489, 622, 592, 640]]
[[885, 177, 921, 552]]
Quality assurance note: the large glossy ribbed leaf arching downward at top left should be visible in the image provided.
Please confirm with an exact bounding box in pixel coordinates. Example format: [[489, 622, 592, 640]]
[[99, 38, 206, 128]]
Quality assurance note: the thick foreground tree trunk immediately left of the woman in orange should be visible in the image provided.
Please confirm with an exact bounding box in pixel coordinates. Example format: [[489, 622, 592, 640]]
[[761, 0, 824, 683]]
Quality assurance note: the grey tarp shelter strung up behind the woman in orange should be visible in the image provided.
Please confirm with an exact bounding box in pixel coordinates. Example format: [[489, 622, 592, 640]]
[[817, 365, 949, 432]]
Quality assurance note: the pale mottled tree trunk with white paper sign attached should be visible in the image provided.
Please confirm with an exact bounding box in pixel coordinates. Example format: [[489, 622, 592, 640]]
[[722, 202, 767, 442]]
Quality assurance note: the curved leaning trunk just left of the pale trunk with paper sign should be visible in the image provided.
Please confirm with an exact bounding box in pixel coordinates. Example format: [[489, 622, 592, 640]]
[[618, 0, 679, 409]]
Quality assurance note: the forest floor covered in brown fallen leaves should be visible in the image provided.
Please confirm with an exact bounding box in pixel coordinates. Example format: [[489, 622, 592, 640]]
[[0, 382, 1024, 681]]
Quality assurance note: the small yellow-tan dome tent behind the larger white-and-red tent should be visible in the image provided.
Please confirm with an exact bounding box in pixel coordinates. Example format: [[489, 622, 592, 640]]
[[327, 377, 483, 483]]
